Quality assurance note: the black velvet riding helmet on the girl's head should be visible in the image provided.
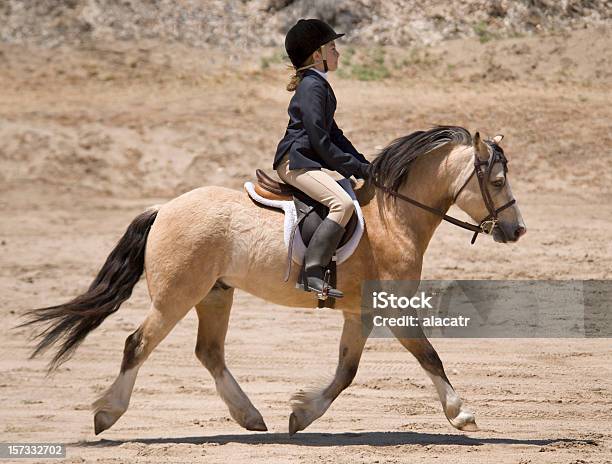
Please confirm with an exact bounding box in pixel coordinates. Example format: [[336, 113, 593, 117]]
[[285, 19, 344, 71]]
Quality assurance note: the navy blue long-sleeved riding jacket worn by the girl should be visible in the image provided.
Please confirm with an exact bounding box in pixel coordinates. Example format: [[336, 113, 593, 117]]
[[272, 69, 370, 178]]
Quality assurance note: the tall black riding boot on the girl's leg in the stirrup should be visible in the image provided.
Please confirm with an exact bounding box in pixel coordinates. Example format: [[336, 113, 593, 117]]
[[304, 218, 344, 298]]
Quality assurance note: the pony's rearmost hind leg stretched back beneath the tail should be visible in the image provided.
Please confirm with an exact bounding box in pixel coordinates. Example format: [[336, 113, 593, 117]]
[[92, 304, 191, 435]]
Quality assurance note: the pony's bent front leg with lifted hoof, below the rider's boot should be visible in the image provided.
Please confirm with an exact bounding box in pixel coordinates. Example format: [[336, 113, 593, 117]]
[[289, 313, 371, 435]]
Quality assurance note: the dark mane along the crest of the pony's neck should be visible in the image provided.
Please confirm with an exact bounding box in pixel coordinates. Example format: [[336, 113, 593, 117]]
[[371, 126, 472, 192]]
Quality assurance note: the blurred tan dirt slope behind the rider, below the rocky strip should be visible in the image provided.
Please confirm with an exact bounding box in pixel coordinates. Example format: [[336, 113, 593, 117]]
[[0, 24, 612, 197]]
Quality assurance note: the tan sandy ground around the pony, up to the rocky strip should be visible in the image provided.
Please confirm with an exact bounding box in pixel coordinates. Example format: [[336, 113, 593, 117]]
[[0, 29, 612, 463]]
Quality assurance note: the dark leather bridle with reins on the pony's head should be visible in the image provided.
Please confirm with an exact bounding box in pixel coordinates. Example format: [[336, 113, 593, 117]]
[[372, 140, 516, 245]]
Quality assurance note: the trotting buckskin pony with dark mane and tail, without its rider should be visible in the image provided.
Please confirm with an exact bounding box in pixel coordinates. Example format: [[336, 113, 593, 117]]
[[22, 126, 526, 434]]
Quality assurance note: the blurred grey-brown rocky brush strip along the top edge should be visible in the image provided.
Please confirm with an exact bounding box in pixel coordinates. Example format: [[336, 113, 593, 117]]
[[0, 0, 612, 48]]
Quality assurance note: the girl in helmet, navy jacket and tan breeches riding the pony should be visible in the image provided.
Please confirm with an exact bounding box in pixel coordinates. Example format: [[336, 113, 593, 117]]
[[273, 19, 370, 298]]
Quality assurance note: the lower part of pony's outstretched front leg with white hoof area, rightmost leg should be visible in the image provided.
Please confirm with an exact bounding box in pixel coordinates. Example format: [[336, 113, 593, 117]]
[[391, 329, 478, 432]]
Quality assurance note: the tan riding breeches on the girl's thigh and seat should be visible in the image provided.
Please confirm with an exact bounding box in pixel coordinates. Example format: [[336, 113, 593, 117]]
[[276, 154, 355, 227]]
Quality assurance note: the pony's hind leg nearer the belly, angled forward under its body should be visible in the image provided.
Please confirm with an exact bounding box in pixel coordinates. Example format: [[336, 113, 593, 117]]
[[195, 285, 268, 431]]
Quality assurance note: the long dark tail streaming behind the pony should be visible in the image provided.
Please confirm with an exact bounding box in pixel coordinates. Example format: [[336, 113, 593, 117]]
[[18, 207, 158, 372]]
